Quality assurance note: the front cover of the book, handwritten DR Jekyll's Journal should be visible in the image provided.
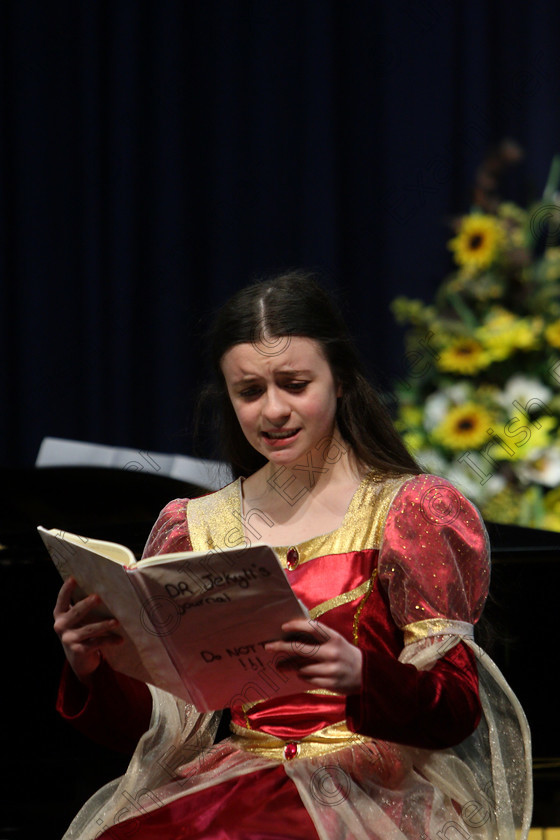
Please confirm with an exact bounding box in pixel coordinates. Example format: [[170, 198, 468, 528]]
[[127, 544, 309, 711]]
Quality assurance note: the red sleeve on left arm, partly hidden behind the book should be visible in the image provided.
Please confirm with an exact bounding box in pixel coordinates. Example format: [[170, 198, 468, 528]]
[[56, 499, 192, 752]]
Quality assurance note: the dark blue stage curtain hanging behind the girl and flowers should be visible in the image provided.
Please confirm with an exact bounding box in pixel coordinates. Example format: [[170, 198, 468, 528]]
[[0, 0, 560, 466]]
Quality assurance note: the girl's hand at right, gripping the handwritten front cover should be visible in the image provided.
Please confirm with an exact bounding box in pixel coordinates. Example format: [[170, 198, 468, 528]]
[[265, 619, 362, 694]]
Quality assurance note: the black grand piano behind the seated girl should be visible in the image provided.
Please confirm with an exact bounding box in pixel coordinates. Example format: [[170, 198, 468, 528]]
[[0, 467, 560, 840]]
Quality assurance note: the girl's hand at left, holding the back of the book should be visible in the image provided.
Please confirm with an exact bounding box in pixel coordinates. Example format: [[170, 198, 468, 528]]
[[53, 578, 123, 683]]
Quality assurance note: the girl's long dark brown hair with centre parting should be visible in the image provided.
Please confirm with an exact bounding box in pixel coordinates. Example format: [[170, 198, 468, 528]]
[[197, 271, 422, 478]]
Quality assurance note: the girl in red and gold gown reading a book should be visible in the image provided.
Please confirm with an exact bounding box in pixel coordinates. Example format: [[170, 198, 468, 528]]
[[55, 273, 531, 840]]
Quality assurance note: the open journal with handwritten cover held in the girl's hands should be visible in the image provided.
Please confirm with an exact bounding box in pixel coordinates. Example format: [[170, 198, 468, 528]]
[[38, 527, 309, 711]]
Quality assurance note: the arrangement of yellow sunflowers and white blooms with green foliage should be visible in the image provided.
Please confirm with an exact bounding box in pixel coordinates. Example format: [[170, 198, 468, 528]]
[[392, 144, 560, 531]]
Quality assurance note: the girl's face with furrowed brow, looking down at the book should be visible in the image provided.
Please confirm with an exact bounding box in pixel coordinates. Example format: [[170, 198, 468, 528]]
[[221, 336, 341, 466]]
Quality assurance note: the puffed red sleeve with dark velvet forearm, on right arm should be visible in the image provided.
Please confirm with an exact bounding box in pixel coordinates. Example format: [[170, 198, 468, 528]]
[[347, 475, 490, 749]]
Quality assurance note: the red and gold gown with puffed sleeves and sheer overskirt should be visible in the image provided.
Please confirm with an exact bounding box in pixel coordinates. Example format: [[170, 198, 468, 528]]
[[59, 472, 531, 840]]
